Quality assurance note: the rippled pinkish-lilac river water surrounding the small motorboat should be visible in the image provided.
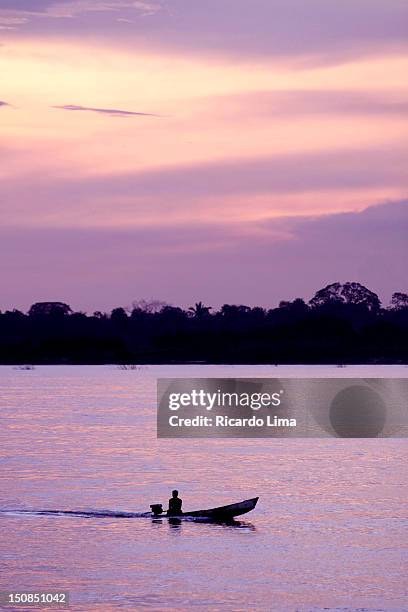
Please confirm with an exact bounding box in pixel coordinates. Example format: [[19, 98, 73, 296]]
[[0, 366, 408, 612]]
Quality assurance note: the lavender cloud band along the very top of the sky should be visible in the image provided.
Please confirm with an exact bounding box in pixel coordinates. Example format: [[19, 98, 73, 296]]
[[0, 0, 408, 66]]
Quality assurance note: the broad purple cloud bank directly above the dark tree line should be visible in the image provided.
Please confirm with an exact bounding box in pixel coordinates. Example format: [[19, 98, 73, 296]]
[[0, 201, 408, 311]]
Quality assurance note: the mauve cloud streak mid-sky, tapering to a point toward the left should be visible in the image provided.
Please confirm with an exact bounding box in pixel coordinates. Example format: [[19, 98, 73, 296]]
[[58, 148, 407, 198]]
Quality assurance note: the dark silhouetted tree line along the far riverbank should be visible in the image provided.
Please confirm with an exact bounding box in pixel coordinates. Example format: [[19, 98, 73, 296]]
[[0, 282, 408, 364]]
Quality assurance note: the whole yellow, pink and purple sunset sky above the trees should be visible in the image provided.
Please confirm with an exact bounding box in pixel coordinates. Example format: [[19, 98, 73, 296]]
[[0, 0, 408, 312]]
